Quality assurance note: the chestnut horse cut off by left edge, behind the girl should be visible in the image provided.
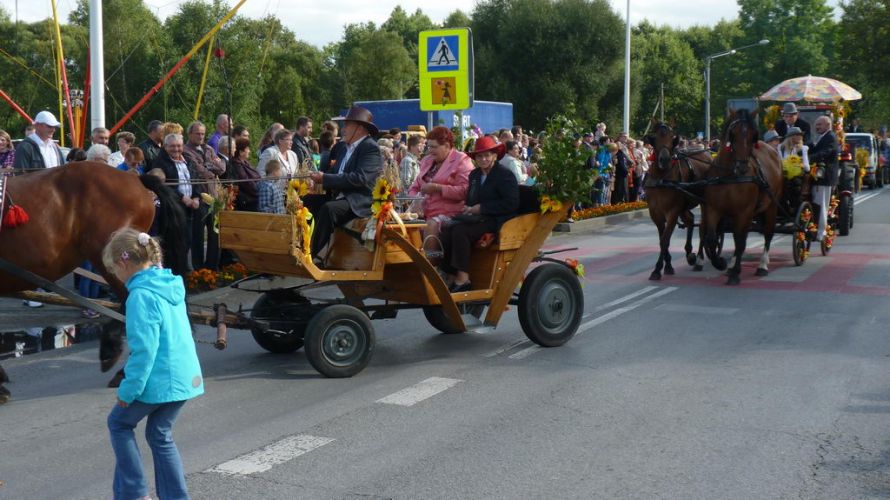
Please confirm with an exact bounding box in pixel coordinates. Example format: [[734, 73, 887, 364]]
[[0, 161, 185, 400]]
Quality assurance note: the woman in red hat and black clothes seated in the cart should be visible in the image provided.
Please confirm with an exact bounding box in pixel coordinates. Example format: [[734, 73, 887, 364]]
[[442, 136, 519, 293]]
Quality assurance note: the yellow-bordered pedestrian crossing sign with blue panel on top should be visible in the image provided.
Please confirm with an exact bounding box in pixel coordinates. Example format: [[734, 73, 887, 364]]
[[417, 28, 473, 111]]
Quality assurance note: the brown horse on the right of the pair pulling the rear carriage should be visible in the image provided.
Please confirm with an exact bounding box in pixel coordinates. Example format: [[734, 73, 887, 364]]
[[703, 109, 783, 285]]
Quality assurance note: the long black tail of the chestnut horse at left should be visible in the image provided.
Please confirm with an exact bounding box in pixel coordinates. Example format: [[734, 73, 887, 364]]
[[139, 174, 189, 276]]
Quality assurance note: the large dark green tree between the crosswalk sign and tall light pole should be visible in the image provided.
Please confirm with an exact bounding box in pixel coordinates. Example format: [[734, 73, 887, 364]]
[[472, 0, 624, 129]]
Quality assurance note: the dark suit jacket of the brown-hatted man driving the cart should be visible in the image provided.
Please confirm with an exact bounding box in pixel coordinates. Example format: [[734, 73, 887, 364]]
[[322, 136, 383, 217]]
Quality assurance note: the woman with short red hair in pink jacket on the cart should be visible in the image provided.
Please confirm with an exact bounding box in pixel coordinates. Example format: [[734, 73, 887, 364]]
[[408, 126, 473, 240]]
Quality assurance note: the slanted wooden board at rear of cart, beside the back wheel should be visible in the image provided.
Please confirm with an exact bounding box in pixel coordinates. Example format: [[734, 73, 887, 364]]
[[485, 209, 560, 326]]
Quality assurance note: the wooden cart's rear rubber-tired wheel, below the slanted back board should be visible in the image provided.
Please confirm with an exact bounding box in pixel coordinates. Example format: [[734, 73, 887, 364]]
[[519, 263, 584, 347]]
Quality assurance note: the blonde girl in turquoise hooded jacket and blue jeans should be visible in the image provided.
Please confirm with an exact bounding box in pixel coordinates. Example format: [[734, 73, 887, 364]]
[[102, 228, 204, 500]]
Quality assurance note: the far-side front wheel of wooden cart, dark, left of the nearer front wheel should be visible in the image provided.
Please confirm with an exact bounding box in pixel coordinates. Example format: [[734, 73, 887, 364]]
[[250, 291, 318, 354]]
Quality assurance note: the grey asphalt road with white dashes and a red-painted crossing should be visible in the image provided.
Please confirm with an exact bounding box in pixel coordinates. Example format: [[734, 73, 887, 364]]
[[0, 190, 890, 499]]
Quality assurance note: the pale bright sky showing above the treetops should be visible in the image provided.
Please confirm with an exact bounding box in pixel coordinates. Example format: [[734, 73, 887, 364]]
[[6, 0, 838, 47]]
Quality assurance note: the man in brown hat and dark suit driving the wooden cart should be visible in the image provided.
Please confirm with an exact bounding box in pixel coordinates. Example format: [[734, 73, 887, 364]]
[[309, 106, 383, 263]]
